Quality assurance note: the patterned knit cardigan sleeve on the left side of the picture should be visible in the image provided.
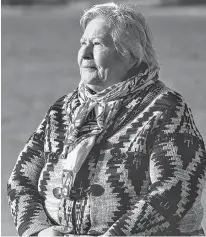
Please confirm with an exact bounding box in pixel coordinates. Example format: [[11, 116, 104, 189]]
[[7, 113, 51, 236]]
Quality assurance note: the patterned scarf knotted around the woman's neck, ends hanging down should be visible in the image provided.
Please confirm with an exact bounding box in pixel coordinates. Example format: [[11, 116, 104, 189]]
[[63, 64, 158, 196]]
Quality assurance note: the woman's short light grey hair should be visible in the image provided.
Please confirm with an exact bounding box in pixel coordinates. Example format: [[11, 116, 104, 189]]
[[80, 2, 159, 69]]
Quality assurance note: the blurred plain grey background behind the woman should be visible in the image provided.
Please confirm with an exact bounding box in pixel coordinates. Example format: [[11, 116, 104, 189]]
[[1, 0, 206, 236]]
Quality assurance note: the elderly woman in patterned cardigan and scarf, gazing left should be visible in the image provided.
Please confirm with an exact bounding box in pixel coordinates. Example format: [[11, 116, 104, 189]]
[[8, 0, 206, 236]]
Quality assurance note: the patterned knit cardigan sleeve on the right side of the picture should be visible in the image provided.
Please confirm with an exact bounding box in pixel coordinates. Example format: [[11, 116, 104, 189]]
[[104, 101, 206, 236]]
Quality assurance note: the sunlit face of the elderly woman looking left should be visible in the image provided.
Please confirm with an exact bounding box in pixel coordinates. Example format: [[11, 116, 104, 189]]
[[78, 18, 128, 92]]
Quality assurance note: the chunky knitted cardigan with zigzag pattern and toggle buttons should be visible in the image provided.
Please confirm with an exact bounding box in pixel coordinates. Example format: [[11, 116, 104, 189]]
[[8, 80, 206, 236]]
